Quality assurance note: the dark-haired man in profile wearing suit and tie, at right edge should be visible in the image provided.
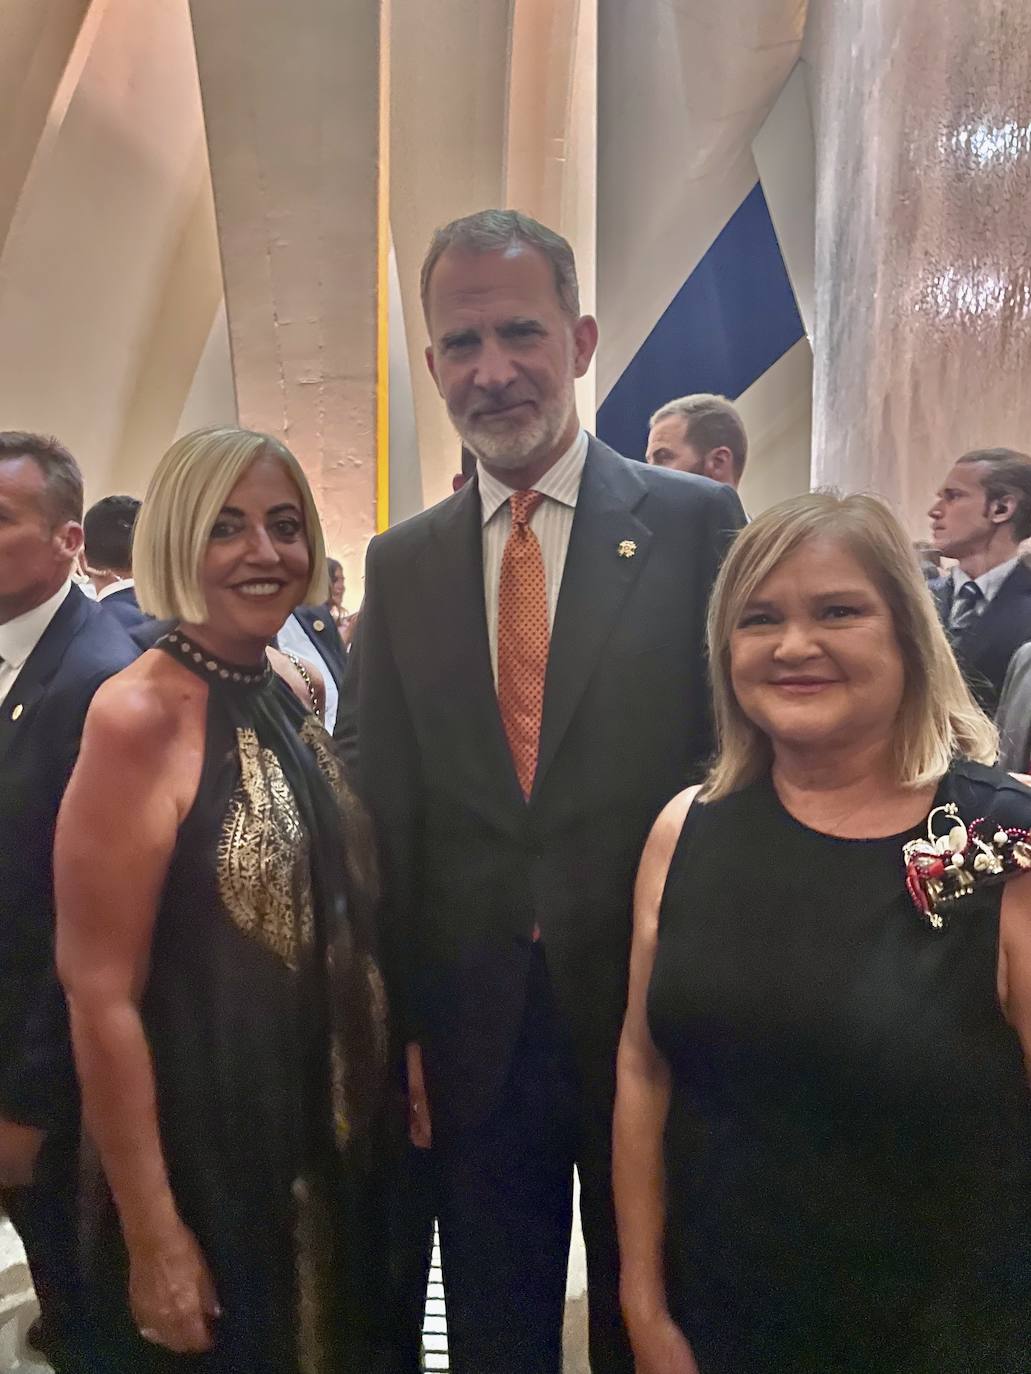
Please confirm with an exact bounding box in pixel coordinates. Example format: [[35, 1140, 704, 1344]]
[[928, 448, 1031, 714]]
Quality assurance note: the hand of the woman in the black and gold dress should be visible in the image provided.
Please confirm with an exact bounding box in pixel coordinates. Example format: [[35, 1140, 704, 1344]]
[[129, 1221, 221, 1355]]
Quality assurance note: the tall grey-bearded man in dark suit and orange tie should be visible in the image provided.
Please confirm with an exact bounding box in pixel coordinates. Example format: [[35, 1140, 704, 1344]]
[[343, 210, 742, 1374]]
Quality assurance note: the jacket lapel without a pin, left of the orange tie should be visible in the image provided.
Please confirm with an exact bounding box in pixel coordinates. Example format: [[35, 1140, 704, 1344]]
[[433, 481, 522, 808]]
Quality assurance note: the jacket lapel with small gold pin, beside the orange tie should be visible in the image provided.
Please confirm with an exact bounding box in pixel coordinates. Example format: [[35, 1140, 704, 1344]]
[[533, 440, 652, 794]]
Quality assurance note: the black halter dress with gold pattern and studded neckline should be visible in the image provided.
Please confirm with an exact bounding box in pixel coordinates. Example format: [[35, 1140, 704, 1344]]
[[84, 632, 385, 1374]]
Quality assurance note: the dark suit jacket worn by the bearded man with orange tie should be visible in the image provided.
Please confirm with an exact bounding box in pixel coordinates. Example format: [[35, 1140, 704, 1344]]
[[341, 440, 744, 1127]]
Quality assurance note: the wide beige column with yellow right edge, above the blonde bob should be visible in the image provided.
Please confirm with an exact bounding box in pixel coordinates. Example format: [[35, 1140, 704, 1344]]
[[191, 0, 379, 587]]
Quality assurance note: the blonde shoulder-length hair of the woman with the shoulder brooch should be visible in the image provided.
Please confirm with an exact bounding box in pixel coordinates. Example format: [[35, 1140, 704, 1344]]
[[702, 492, 998, 801]]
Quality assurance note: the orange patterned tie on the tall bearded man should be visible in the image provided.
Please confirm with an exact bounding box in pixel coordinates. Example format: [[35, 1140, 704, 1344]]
[[498, 492, 548, 797]]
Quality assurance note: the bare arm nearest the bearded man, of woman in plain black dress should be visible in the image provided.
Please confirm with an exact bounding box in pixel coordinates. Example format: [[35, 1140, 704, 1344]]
[[613, 787, 698, 1374]]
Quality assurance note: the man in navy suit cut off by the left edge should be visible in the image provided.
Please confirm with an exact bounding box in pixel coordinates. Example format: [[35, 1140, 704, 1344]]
[[0, 431, 136, 1374]]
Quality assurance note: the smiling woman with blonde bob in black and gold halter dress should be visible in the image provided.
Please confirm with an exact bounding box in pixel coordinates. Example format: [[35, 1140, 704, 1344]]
[[55, 429, 385, 1374]]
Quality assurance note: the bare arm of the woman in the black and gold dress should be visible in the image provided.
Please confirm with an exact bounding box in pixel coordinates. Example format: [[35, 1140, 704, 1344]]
[[55, 675, 213, 1351]]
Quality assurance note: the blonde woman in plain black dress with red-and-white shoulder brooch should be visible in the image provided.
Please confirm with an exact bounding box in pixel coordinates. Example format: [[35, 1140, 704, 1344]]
[[613, 492, 1031, 1374]]
